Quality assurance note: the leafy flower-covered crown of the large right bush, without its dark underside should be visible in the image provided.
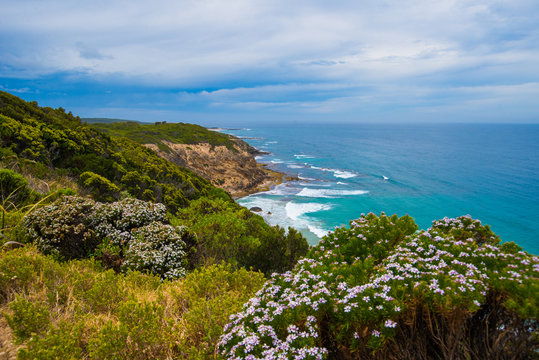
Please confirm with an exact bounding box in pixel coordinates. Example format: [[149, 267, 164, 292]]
[[219, 214, 539, 359]]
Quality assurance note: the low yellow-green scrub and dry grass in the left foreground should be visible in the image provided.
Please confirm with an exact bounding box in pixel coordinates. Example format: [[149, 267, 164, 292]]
[[0, 246, 264, 359]]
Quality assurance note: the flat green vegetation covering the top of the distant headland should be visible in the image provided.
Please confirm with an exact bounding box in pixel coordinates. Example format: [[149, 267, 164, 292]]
[[90, 121, 236, 151]]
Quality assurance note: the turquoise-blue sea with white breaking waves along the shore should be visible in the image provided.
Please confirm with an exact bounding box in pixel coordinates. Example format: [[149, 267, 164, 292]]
[[223, 124, 539, 254]]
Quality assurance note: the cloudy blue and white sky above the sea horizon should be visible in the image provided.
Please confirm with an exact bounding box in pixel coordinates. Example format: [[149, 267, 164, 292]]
[[0, 0, 539, 126]]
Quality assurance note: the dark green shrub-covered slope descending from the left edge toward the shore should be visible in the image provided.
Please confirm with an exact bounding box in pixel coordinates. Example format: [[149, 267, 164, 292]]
[[0, 91, 232, 212]]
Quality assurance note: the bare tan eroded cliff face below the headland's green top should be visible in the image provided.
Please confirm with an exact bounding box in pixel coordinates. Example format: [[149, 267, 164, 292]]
[[145, 139, 282, 198]]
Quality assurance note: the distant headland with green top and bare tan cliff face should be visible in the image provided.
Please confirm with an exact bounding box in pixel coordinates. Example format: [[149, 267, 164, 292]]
[[90, 122, 282, 197]]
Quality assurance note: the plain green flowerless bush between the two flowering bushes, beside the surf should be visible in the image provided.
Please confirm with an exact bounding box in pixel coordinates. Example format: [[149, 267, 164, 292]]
[[177, 198, 308, 274]]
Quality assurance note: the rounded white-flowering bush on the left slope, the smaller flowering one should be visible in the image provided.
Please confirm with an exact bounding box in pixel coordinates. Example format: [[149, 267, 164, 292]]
[[24, 197, 194, 278]]
